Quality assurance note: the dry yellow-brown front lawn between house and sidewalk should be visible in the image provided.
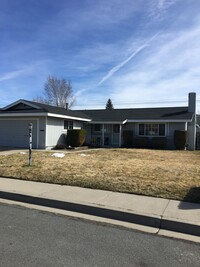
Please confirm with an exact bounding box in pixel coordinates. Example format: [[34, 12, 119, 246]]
[[0, 149, 200, 203]]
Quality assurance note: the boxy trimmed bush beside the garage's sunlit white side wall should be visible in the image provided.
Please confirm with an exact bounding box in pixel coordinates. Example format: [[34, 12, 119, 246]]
[[66, 129, 86, 147]]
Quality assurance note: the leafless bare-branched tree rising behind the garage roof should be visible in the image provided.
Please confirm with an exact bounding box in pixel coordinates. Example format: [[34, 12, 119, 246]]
[[33, 76, 75, 108]]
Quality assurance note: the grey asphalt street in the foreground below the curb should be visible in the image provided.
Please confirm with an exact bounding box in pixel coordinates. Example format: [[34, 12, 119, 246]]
[[0, 204, 200, 267]]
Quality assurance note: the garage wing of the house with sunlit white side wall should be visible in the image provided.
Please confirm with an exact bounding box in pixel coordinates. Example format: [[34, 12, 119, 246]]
[[0, 100, 90, 149]]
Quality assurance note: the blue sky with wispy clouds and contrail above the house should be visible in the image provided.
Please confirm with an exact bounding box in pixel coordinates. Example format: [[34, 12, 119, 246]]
[[0, 0, 200, 112]]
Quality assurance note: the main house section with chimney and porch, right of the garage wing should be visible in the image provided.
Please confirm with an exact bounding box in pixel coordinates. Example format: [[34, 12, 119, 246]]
[[79, 93, 196, 150]]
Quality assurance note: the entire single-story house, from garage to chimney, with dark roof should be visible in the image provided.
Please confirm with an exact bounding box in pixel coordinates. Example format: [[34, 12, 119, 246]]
[[0, 93, 198, 150]]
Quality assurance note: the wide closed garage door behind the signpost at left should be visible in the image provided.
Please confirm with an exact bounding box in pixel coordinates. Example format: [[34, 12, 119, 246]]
[[0, 119, 37, 148]]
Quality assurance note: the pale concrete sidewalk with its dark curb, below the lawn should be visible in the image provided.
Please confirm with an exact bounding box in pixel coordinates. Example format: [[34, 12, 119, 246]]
[[0, 178, 200, 241]]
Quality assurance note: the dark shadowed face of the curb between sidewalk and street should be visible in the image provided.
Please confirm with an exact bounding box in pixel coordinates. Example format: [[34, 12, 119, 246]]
[[0, 191, 200, 236]]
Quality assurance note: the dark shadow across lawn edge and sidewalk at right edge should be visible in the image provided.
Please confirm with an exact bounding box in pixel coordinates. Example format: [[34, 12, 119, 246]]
[[179, 187, 200, 210]]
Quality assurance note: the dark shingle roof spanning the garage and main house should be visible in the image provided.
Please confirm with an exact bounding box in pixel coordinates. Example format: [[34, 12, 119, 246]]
[[0, 100, 194, 123]]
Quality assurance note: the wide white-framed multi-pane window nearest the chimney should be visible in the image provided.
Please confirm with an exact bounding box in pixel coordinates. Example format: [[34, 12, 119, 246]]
[[139, 123, 165, 136]]
